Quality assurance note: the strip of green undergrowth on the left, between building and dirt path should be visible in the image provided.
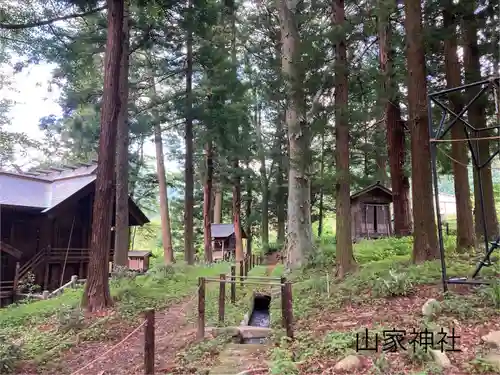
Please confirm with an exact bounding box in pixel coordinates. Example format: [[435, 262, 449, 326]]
[[0, 263, 229, 373]]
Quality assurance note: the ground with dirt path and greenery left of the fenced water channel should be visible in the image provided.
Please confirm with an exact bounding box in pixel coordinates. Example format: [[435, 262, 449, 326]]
[[0, 263, 236, 375]]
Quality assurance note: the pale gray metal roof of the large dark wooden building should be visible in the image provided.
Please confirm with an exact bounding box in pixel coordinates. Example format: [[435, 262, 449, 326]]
[[0, 165, 97, 211]]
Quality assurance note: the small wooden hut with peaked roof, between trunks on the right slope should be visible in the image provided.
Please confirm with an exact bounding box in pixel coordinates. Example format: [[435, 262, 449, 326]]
[[351, 181, 392, 241]]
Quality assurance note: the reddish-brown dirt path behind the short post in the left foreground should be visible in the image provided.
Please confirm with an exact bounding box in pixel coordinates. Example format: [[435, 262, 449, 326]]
[[48, 296, 196, 375]]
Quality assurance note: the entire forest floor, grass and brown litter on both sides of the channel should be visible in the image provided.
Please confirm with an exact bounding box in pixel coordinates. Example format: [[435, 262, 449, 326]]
[[0, 236, 500, 375]]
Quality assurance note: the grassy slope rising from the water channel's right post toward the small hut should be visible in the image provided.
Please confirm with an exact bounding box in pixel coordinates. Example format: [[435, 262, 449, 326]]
[[271, 237, 500, 375]]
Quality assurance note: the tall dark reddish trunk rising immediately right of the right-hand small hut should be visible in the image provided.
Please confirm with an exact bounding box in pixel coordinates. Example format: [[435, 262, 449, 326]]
[[378, 1, 411, 236]]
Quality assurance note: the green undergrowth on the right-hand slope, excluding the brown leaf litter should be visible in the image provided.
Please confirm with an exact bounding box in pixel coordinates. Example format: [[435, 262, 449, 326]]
[[270, 236, 500, 375]]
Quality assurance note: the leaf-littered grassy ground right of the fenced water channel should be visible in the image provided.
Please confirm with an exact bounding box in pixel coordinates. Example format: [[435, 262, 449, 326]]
[[170, 237, 500, 375]]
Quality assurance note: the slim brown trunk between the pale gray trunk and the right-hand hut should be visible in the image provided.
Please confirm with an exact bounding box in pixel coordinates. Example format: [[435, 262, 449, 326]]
[[332, 0, 356, 278]]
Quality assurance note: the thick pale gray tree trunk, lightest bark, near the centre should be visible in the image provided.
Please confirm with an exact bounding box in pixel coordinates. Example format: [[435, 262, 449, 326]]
[[279, 0, 313, 268]]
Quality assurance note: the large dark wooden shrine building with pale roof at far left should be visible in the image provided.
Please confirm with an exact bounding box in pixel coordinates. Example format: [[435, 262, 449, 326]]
[[0, 162, 149, 306]]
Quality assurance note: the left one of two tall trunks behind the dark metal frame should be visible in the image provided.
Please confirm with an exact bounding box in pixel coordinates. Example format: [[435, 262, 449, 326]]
[[441, 0, 475, 251]]
